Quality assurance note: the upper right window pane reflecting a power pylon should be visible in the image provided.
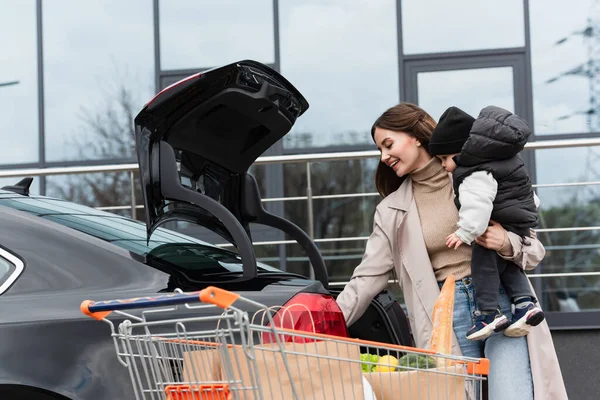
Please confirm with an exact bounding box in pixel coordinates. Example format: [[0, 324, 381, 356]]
[[529, 0, 600, 135]]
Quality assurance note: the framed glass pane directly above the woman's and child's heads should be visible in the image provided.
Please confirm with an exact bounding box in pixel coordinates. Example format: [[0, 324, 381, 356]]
[[417, 67, 515, 121]]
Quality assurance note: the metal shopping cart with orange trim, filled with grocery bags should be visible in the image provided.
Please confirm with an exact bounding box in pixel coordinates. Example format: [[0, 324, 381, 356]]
[[81, 287, 489, 400]]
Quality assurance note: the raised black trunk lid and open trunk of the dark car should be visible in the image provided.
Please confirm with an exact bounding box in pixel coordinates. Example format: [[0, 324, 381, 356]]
[[135, 60, 412, 345]]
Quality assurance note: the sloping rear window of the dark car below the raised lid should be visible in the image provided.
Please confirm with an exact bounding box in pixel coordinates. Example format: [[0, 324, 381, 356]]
[[0, 197, 278, 274]]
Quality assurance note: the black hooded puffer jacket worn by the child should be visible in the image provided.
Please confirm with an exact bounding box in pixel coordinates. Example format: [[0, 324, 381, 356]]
[[452, 106, 538, 236]]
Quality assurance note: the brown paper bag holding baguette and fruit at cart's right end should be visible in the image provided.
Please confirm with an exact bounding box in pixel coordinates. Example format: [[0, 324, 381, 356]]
[[364, 366, 466, 400]]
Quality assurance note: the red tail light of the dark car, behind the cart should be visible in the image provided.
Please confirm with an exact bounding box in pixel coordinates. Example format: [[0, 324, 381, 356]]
[[263, 293, 348, 343]]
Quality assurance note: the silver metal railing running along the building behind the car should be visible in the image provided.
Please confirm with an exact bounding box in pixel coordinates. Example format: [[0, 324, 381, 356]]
[[0, 138, 600, 284]]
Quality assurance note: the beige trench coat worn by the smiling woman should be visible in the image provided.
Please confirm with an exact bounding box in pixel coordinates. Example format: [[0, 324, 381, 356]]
[[337, 178, 567, 400]]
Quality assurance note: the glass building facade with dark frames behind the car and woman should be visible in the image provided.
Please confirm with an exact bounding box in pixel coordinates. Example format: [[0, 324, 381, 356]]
[[0, 0, 600, 384]]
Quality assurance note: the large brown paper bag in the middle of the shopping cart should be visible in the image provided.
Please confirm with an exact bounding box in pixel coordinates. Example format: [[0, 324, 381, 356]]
[[221, 341, 364, 400]]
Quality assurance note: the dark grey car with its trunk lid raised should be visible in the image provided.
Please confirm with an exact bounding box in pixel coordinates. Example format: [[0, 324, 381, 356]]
[[0, 61, 410, 400]]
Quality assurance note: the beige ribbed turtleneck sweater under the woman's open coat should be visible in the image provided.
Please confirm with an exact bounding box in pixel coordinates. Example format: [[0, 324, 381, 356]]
[[410, 157, 471, 281]]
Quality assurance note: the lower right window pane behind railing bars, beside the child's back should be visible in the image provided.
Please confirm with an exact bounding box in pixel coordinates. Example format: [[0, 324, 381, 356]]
[[536, 147, 600, 311]]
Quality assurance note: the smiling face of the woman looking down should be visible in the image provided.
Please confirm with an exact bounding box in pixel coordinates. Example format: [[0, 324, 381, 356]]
[[373, 128, 431, 176]]
